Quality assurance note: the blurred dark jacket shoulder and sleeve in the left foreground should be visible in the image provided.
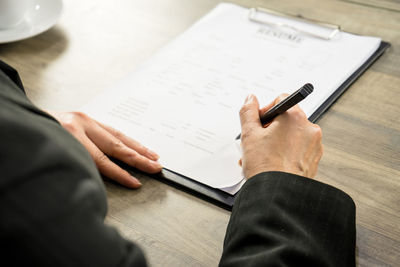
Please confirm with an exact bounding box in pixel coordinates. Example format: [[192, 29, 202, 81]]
[[0, 62, 146, 266]]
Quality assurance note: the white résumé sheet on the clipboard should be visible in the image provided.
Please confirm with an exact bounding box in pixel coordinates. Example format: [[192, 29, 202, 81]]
[[82, 4, 381, 194]]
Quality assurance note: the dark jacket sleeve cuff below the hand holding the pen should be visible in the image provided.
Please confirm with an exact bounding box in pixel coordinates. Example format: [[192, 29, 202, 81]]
[[220, 172, 355, 267]]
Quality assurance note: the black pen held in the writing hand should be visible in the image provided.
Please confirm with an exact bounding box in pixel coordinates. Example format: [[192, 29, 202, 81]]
[[236, 83, 314, 139]]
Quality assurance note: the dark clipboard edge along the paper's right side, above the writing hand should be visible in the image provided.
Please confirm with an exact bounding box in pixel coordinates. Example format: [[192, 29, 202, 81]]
[[308, 41, 390, 122]]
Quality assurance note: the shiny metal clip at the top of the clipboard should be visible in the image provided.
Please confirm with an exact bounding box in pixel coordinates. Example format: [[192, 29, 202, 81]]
[[249, 7, 340, 40]]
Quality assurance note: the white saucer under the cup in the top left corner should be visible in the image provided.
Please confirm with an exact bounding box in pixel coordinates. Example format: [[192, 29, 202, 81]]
[[0, 0, 62, 43]]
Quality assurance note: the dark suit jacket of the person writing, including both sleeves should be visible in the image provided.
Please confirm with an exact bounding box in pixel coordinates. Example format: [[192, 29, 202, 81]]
[[0, 61, 355, 266]]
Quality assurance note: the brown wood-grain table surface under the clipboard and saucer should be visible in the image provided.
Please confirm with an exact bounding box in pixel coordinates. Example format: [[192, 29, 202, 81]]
[[0, 0, 400, 266]]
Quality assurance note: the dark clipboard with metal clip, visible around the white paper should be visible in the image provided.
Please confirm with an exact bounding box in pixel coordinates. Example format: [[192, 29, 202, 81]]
[[141, 8, 390, 210]]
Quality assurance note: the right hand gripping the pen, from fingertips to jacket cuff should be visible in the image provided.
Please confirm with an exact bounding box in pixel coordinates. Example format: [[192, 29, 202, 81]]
[[240, 95, 323, 179]]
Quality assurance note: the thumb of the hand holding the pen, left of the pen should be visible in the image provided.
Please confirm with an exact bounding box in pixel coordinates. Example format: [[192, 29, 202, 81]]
[[239, 94, 261, 137]]
